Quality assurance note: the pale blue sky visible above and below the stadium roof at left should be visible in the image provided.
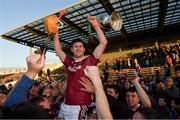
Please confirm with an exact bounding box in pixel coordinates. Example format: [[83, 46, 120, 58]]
[[0, 0, 80, 69]]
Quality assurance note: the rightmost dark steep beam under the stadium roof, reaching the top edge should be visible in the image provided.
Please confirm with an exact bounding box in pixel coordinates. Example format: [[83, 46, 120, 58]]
[[158, 0, 168, 35]]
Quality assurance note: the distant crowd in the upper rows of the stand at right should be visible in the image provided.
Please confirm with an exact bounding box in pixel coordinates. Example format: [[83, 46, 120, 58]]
[[110, 43, 180, 70]]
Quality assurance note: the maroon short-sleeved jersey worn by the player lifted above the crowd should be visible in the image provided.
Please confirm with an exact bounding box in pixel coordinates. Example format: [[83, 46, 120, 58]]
[[64, 54, 98, 105]]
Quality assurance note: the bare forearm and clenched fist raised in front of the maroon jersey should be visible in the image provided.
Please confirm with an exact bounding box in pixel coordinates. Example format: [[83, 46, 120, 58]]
[[84, 66, 112, 119]]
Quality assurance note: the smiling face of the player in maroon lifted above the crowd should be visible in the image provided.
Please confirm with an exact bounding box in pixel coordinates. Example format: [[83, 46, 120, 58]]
[[71, 42, 85, 57]]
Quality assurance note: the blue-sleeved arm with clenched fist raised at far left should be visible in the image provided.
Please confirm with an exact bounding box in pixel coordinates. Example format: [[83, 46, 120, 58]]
[[4, 53, 45, 107]]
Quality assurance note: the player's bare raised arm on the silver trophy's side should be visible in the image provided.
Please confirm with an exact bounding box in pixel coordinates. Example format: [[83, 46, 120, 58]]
[[88, 16, 107, 59]]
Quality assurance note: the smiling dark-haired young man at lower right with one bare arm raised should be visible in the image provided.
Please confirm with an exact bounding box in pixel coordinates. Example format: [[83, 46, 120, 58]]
[[120, 70, 151, 119]]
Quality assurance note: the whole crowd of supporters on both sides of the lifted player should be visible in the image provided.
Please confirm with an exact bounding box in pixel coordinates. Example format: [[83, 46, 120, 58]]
[[0, 43, 180, 119]]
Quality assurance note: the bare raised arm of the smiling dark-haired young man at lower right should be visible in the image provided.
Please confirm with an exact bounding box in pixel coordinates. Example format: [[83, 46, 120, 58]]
[[131, 70, 151, 108]]
